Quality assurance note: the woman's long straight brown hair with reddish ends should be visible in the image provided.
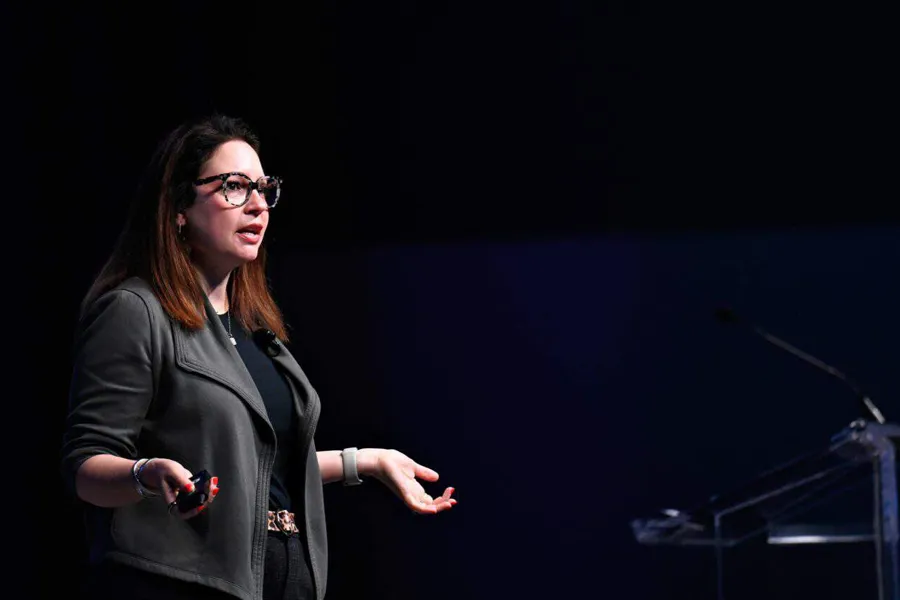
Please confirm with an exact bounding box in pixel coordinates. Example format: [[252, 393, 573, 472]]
[[81, 115, 288, 341]]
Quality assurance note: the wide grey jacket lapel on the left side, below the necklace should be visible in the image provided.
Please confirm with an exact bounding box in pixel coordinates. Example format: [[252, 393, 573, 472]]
[[174, 298, 275, 437]]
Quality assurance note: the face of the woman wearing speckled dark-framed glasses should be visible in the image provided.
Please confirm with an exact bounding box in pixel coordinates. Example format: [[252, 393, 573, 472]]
[[176, 140, 269, 276]]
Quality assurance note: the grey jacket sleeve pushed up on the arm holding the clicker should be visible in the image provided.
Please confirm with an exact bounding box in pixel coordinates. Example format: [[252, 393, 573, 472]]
[[60, 290, 154, 497]]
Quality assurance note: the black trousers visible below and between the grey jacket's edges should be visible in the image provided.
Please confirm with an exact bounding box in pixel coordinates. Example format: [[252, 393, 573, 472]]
[[83, 531, 315, 600]]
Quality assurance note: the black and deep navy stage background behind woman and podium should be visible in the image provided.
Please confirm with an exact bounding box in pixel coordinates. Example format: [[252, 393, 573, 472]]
[[0, 1, 900, 599]]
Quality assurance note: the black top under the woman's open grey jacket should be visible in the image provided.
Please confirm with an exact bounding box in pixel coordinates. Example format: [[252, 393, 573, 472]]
[[219, 312, 297, 510]]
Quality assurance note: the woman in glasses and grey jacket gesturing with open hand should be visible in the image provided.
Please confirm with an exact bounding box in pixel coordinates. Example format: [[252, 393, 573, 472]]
[[61, 116, 456, 600]]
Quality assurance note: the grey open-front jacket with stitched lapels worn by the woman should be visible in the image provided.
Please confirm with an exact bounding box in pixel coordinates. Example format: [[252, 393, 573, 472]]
[[61, 278, 328, 600]]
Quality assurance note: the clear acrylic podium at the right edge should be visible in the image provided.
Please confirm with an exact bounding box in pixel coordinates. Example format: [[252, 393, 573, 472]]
[[631, 420, 900, 600]]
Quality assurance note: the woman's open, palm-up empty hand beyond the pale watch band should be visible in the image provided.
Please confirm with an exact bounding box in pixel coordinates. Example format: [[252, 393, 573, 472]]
[[369, 448, 456, 514]]
